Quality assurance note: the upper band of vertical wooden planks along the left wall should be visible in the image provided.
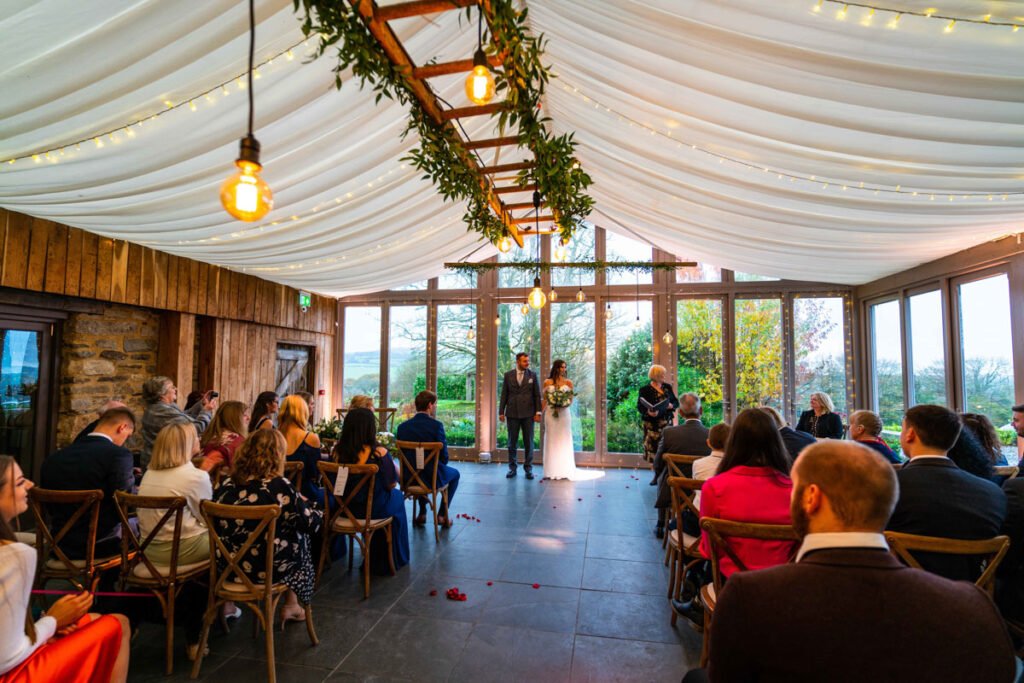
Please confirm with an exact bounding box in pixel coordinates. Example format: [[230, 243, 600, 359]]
[[0, 209, 337, 337]]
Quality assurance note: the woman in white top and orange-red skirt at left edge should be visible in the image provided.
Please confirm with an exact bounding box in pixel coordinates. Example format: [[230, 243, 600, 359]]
[[0, 454, 131, 683]]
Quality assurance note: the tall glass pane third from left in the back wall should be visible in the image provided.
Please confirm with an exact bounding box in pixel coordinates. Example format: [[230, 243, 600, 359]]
[[437, 304, 477, 446]]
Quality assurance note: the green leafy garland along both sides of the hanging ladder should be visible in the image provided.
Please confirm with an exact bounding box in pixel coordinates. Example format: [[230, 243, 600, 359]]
[[293, 0, 594, 243]]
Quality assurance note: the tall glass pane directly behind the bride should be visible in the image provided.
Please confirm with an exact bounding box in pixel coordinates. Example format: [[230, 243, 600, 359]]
[[552, 302, 597, 451]]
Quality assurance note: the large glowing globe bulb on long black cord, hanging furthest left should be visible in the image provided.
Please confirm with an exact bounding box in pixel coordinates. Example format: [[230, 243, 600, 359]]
[[220, 0, 273, 221]]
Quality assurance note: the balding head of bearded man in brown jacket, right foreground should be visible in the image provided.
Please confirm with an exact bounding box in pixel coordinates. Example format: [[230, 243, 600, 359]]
[[791, 440, 899, 536]]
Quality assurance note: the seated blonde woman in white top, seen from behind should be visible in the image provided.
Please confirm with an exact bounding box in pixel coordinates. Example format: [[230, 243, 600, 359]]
[[138, 422, 213, 565]]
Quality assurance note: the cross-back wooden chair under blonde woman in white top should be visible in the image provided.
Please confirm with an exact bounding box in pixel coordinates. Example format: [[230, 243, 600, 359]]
[[114, 490, 210, 675]]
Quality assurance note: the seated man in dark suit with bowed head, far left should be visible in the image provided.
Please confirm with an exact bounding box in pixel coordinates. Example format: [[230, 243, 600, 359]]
[[42, 408, 135, 559]]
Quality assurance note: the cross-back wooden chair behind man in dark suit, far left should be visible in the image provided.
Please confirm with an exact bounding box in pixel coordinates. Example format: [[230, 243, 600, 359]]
[[29, 486, 122, 592]]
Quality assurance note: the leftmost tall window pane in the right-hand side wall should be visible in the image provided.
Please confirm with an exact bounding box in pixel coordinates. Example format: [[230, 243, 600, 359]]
[[869, 301, 905, 430]]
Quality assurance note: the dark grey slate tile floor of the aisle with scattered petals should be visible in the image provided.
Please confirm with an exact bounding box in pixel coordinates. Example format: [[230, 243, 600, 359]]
[[129, 463, 700, 683]]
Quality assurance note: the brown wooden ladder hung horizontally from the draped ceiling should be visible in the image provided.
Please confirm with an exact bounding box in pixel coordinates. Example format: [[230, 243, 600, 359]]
[[350, 0, 558, 247]]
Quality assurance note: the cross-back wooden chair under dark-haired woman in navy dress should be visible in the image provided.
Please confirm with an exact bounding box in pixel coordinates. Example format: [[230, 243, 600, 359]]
[[316, 462, 395, 598]]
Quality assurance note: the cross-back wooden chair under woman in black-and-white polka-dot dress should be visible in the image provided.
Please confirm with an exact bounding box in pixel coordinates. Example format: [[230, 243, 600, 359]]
[[191, 501, 319, 683]]
